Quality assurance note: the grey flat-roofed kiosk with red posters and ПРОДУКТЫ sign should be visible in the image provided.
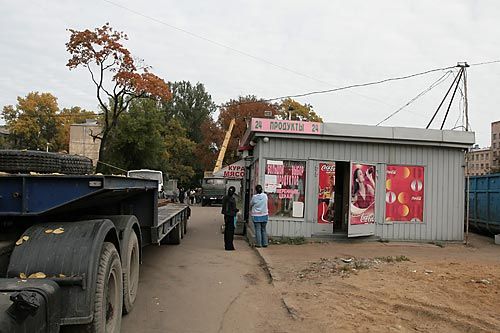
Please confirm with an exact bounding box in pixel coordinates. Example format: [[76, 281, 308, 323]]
[[242, 119, 474, 241]]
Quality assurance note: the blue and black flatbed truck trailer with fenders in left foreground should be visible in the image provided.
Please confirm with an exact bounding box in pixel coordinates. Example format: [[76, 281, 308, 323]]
[[0, 151, 190, 333]]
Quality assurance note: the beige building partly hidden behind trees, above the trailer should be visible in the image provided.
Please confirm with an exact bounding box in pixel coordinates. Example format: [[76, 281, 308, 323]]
[[69, 120, 101, 166]]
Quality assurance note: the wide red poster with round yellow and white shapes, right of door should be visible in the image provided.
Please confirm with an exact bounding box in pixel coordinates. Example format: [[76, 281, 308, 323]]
[[385, 165, 424, 222]]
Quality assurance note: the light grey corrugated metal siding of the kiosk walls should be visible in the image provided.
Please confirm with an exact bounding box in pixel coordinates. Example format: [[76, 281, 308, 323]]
[[255, 137, 465, 241]]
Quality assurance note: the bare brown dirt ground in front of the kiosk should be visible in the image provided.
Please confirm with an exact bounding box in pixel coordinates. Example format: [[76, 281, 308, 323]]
[[258, 235, 500, 332]]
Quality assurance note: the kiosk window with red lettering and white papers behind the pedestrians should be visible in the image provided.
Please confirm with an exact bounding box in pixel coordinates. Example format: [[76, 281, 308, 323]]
[[264, 160, 306, 217]]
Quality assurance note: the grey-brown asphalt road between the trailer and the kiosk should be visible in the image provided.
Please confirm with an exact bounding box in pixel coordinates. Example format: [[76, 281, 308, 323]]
[[122, 207, 293, 333]]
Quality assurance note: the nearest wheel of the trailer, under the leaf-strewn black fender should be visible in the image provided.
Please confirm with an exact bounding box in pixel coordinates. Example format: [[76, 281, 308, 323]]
[[90, 242, 123, 333]]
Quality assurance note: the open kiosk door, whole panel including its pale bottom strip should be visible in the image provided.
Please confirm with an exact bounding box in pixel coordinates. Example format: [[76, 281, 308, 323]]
[[347, 163, 376, 237]]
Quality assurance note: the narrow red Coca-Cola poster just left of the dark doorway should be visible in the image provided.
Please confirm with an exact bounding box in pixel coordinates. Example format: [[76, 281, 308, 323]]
[[318, 162, 335, 223]]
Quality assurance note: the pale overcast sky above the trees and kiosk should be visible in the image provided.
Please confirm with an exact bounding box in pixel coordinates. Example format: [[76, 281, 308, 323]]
[[0, 0, 500, 147]]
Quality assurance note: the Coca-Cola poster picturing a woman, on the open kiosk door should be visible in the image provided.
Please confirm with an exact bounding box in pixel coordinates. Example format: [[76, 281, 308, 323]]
[[349, 164, 376, 225]]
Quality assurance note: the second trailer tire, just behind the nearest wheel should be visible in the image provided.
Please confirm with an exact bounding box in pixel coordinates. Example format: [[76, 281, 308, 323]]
[[123, 231, 140, 314]]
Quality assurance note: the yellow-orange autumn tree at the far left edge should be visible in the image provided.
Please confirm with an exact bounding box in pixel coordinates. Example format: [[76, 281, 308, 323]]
[[3, 92, 64, 151]]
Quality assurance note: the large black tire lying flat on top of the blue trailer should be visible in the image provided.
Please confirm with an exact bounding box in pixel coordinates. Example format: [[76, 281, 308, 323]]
[[0, 150, 93, 175]]
